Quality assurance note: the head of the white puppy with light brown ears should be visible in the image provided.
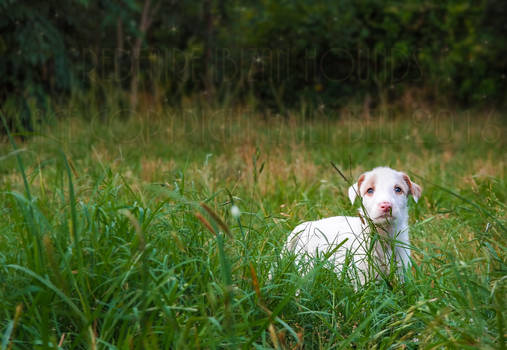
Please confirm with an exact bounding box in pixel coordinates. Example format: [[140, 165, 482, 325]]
[[349, 167, 421, 224]]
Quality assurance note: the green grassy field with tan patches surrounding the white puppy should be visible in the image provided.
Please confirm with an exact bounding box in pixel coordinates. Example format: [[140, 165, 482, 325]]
[[0, 106, 507, 350]]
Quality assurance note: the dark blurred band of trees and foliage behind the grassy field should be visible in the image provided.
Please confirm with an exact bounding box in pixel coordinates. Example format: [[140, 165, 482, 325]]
[[0, 0, 507, 127]]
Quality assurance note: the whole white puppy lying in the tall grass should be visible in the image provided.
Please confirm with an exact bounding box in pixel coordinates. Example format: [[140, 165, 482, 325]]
[[286, 167, 421, 284]]
